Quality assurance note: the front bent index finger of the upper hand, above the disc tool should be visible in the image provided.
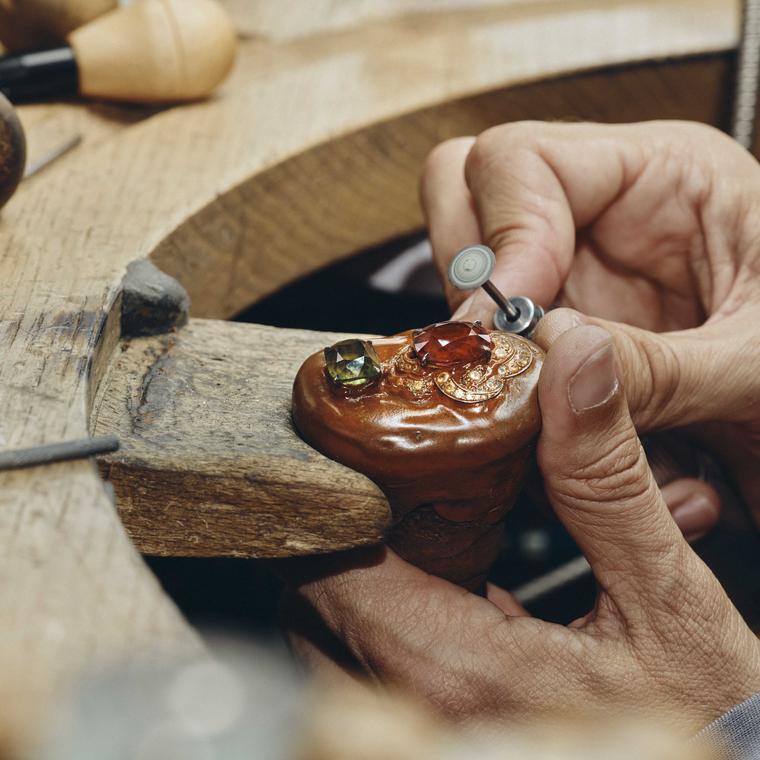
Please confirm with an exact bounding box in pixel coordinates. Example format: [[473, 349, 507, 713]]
[[465, 122, 641, 307]]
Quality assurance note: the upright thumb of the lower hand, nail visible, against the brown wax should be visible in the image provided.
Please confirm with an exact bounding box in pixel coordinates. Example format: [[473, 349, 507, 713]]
[[538, 325, 686, 595]]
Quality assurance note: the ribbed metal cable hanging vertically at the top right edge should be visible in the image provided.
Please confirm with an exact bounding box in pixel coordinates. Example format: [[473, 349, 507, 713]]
[[731, 0, 760, 150]]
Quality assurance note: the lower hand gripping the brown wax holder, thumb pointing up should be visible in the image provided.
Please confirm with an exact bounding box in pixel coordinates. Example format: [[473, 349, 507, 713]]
[[282, 326, 760, 731]]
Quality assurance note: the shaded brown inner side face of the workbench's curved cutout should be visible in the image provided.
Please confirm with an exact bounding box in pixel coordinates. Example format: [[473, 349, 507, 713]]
[[153, 57, 730, 318]]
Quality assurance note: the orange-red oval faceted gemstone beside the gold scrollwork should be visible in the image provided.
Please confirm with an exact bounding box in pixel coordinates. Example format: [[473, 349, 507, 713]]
[[413, 322, 493, 367]]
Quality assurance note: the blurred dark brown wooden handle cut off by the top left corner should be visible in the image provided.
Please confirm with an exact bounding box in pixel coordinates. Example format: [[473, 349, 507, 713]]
[[0, 0, 118, 50]]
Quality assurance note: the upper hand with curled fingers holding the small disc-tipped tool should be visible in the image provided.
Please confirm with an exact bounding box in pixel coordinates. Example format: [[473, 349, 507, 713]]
[[422, 122, 760, 524]]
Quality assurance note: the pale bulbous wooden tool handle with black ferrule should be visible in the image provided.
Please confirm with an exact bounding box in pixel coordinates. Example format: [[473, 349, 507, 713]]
[[0, 0, 237, 103]]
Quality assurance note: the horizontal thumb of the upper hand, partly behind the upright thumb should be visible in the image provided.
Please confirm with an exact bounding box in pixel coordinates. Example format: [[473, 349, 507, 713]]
[[534, 307, 760, 432]]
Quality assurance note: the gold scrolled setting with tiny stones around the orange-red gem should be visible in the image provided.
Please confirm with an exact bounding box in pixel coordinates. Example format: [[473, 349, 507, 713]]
[[384, 332, 534, 404]]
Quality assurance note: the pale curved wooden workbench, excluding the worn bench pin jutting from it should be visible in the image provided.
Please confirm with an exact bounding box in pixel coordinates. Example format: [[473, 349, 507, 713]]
[[0, 0, 738, 748]]
